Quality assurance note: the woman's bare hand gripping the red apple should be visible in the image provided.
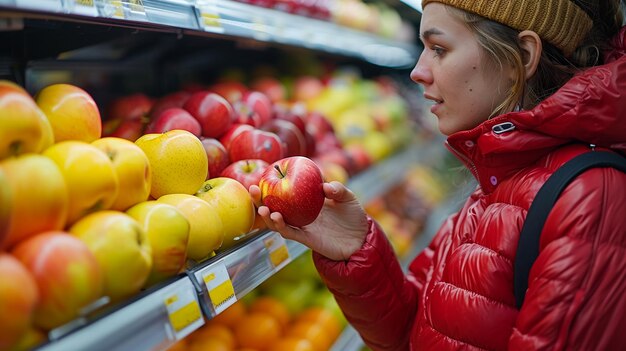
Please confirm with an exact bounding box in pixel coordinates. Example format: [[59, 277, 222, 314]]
[[250, 182, 368, 261]]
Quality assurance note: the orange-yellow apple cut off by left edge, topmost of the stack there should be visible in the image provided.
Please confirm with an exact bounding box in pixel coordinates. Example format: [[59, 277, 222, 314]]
[[0, 80, 53, 159]]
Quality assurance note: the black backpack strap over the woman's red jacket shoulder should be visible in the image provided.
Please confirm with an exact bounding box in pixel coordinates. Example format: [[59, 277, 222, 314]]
[[513, 151, 626, 309]]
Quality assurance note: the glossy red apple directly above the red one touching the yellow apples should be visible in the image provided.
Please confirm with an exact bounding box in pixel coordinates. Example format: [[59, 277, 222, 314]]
[[183, 91, 233, 138]]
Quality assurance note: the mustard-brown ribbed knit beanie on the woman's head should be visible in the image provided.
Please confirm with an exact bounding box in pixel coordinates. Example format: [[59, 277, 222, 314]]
[[422, 0, 593, 56]]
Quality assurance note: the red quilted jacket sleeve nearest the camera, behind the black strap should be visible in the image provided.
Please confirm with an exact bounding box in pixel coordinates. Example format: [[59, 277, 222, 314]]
[[509, 168, 626, 350]]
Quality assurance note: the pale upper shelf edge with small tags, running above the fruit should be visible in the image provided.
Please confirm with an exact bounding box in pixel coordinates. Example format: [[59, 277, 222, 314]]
[[0, 0, 418, 68]]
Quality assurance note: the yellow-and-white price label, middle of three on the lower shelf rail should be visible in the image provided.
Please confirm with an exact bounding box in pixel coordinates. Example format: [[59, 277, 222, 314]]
[[200, 263, 237, 314]]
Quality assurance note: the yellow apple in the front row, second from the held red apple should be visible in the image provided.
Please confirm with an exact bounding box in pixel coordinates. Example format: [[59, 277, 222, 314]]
[[158, 194, 224, 262]]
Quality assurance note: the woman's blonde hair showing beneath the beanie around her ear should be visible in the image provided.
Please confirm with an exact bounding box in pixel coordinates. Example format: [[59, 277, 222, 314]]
[[447, 0, 623, 118]]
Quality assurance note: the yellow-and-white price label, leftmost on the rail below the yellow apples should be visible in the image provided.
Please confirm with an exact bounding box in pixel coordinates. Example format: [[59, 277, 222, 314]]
[[163, 280, 204, 340]]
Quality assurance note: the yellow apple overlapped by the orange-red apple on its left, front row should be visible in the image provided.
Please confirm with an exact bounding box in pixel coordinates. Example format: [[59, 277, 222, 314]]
[[69, 210, 152, 301]]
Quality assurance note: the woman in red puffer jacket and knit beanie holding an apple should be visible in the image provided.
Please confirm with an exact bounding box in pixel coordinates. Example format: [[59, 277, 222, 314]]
[[251, 0, 626, 350]]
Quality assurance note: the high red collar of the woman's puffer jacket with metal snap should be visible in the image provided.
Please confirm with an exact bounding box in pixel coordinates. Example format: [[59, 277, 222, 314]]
[[446, 27, 626, 193]]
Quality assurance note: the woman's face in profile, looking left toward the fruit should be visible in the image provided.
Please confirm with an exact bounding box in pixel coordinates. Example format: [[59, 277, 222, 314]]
[[411, 3, 511, 135]]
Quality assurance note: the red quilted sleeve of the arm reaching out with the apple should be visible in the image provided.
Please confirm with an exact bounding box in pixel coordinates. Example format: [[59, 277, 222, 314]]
[[313, 214, 454, 350]]
